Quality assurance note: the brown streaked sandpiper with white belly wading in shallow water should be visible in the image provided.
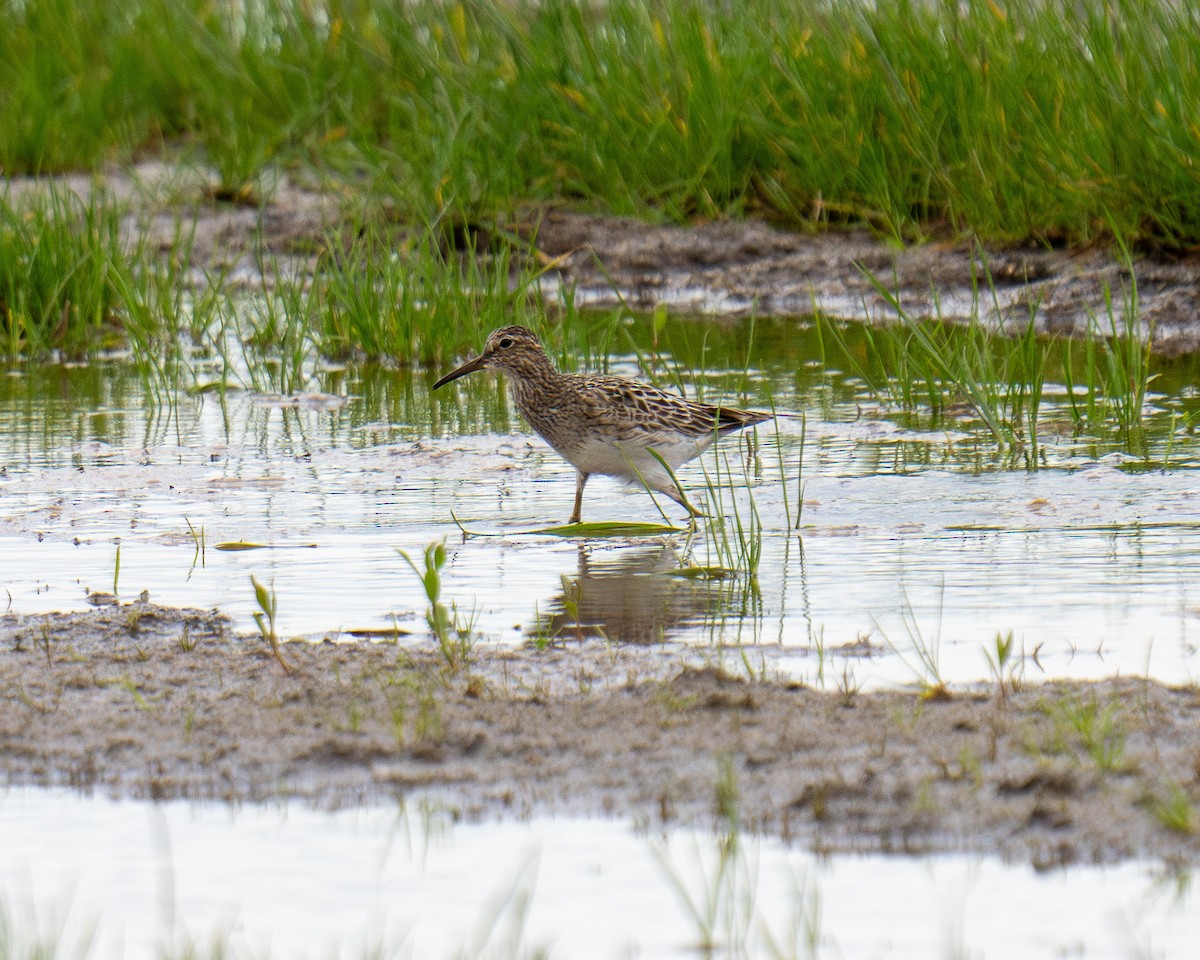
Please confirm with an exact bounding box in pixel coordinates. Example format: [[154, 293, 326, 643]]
[[433, 326, 772, 523]]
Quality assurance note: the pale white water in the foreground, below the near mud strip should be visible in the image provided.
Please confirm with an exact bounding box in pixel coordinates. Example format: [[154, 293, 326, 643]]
[[0, 791, 1200, 958]]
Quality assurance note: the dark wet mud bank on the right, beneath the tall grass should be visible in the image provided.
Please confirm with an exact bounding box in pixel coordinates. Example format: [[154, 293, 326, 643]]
[[536, 212, 1200, 355]]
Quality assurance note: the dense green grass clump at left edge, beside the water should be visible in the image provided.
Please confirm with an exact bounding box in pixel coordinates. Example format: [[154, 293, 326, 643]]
[[0, 191, 132, 359]]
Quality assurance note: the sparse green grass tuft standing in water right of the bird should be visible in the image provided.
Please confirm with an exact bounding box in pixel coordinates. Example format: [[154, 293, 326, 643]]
[[818, 246, 1156, 469]]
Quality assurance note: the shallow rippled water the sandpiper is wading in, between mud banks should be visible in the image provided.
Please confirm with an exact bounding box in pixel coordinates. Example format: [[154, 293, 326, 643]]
[[0, 320, 1200, 686]]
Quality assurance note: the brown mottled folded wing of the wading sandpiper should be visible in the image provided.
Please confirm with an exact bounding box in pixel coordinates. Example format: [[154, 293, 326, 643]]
[[580, 377, 770, 440]]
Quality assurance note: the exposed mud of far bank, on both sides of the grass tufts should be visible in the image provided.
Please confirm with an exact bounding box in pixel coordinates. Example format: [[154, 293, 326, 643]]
[[14, 162, 1200, 354]]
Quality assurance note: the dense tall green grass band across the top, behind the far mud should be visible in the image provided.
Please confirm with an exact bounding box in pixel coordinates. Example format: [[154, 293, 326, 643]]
[[0, 0, 1200, 247]]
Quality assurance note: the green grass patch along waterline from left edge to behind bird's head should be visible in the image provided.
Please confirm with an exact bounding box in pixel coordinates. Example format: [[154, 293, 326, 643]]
[[0, 186, 552, 369]]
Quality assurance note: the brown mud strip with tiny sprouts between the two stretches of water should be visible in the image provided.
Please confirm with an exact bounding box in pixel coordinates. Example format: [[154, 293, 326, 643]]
[[0, 602, 1200, 866]]
